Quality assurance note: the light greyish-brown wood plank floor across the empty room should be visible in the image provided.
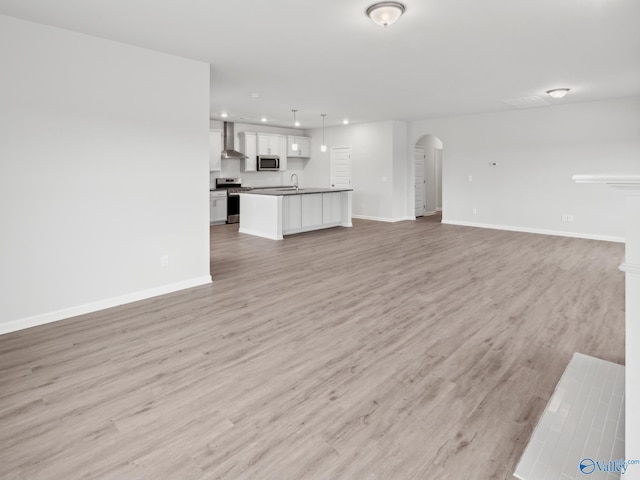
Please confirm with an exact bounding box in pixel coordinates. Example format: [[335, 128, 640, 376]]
[[0, 218, 624, 480]]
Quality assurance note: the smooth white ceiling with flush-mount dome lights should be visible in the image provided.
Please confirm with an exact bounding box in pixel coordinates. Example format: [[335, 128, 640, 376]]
[[0, 0, 640, 128]]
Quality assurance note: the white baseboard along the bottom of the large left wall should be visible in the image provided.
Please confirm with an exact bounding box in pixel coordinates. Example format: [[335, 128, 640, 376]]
[[0, 275, 211, 335]]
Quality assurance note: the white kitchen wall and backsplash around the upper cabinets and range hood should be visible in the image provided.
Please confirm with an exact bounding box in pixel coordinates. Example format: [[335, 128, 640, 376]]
[[209, 120, 308, 188]]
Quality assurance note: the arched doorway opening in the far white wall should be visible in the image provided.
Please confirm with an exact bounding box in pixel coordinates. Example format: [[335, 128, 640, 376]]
[[413, 134, 443, 217]]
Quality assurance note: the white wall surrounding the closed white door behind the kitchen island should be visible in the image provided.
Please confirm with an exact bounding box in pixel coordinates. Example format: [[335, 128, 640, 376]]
[[305, 121, 407, 221]]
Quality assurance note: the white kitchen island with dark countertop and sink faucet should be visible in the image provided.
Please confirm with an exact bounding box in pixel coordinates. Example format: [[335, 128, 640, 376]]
[[240, 187, 352, 240]]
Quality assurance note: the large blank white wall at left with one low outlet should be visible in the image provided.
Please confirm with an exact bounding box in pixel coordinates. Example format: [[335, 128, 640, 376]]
[[0, 16, 211, 333]]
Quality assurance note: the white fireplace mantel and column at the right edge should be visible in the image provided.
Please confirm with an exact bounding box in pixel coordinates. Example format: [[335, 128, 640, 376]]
[[573, 175, 640, 460]]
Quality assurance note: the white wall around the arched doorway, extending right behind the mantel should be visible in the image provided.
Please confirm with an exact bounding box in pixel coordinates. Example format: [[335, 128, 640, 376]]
[[407, 97, 640, 240]]
